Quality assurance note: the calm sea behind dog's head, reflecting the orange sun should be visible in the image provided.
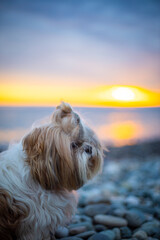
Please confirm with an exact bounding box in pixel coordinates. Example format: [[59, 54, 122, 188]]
[[0, 107, 160, 145]]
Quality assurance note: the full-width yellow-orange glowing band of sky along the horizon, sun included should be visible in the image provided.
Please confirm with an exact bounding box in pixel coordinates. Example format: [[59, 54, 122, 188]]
[[0, 72, 160, 107]]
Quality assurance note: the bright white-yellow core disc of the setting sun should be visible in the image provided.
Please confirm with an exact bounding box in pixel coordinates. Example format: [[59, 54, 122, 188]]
[[112, 87, 135, 101]]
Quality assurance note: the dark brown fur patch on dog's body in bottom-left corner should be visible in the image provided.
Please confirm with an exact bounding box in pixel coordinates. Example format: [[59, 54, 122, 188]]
[[0, 189, 29, 240]]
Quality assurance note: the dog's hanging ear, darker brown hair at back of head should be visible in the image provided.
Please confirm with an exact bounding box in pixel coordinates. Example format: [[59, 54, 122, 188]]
[[23, 127, 55, 189]]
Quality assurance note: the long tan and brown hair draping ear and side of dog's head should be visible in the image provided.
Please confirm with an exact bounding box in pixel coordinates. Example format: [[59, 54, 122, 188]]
[[23, 126, 83, 190]]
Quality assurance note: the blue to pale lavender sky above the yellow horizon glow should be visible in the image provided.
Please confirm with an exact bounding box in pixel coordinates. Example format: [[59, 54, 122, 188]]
[[0, 0, 160, 90]]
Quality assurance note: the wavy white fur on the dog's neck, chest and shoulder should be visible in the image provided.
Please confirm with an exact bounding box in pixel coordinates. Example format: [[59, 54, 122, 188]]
[[0, 142, 76, 240]]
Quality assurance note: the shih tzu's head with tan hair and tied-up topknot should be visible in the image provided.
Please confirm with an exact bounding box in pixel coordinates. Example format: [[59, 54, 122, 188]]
[[23, 103, 103, 191]]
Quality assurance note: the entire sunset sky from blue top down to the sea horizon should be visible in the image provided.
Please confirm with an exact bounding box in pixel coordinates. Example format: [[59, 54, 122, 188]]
[[0, 0, 160, 107]]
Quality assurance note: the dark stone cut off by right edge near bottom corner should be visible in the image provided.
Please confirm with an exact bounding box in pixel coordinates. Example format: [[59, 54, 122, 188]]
[[141, 221, 160, 236]]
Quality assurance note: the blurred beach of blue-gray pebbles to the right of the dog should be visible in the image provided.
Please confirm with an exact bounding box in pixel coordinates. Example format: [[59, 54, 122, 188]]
[[55, 141, 160, 240]]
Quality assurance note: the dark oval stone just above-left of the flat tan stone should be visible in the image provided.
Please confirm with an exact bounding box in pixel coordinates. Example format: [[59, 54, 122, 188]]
[[84, 203, 109, 217]]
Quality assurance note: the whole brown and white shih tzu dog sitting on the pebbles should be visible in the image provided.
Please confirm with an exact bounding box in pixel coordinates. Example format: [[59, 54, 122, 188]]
[[0, 103, 103, 240]]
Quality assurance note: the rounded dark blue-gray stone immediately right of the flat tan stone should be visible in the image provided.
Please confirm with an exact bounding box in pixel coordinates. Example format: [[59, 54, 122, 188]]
[[125, 210, 146, 228]]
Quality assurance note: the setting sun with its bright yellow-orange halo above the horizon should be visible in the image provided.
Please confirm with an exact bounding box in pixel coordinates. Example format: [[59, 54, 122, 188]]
[[96, 85, 160, 107]]
